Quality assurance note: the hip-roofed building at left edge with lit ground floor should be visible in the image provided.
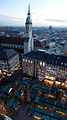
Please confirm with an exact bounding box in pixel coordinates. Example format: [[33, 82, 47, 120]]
[[0, 49, 20, 75]]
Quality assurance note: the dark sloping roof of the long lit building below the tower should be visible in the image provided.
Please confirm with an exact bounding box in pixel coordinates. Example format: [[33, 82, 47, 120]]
[[23, 51, 67, 67]]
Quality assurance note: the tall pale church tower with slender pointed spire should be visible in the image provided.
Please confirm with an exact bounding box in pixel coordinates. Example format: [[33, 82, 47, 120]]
[[24, 4, 33, 54]]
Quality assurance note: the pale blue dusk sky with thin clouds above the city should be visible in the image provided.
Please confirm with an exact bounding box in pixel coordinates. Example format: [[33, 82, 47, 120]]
[[0, 0, 67, 26]]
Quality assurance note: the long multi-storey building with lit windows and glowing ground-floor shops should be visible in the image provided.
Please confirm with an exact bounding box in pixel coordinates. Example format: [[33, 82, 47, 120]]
[[23, 51, 67, 88]]
